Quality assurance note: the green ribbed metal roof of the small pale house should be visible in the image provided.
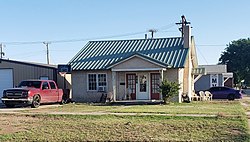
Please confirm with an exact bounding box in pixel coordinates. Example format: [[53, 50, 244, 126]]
[[69, 37, 188, 70]]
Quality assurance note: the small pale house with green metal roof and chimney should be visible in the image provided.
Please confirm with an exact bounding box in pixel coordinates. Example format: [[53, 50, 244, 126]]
[[69, 26, 197, 102]]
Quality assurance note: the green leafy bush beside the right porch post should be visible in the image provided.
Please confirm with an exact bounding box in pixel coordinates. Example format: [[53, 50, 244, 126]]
[[160, 80, 180, 104]]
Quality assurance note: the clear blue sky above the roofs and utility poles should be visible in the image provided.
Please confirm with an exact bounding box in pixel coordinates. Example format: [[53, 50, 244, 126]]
[[0, 0, 250, 64]]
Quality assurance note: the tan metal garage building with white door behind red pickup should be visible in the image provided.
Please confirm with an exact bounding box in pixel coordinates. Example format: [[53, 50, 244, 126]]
[[0, 59, 58, 97]]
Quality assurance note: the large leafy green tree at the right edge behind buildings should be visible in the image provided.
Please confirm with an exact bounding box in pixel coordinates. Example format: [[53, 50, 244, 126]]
[[219, 38, 250, 83]]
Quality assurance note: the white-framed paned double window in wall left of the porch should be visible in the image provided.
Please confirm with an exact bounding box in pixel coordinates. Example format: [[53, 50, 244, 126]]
[[88, 74, 107, 91]]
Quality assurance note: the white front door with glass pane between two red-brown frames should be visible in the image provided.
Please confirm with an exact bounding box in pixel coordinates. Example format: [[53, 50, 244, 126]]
[[136, 73, 149, 100]]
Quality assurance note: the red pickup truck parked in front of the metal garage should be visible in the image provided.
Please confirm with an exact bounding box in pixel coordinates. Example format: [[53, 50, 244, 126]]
[[2, 80, 63, 108]]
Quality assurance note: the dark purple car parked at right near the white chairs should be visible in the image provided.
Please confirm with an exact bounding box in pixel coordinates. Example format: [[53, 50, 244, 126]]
[[208, 86, 242, 100]]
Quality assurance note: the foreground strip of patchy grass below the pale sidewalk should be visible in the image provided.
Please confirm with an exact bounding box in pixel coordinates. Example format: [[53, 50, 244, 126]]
[[0, 115, 249, 142]]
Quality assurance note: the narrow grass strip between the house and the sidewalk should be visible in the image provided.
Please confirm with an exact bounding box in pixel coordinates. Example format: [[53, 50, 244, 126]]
[[28, 101, 245, 115]]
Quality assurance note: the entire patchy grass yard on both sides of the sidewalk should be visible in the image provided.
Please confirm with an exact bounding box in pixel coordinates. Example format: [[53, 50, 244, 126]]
[[0, 101, 250, 142]]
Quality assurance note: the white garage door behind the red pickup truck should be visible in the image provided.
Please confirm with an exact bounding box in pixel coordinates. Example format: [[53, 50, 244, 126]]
[[0, 69, 13, 98]]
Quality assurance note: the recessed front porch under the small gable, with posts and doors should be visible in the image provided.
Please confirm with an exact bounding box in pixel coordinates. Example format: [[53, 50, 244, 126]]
[[112, 70, 163, 103]]
